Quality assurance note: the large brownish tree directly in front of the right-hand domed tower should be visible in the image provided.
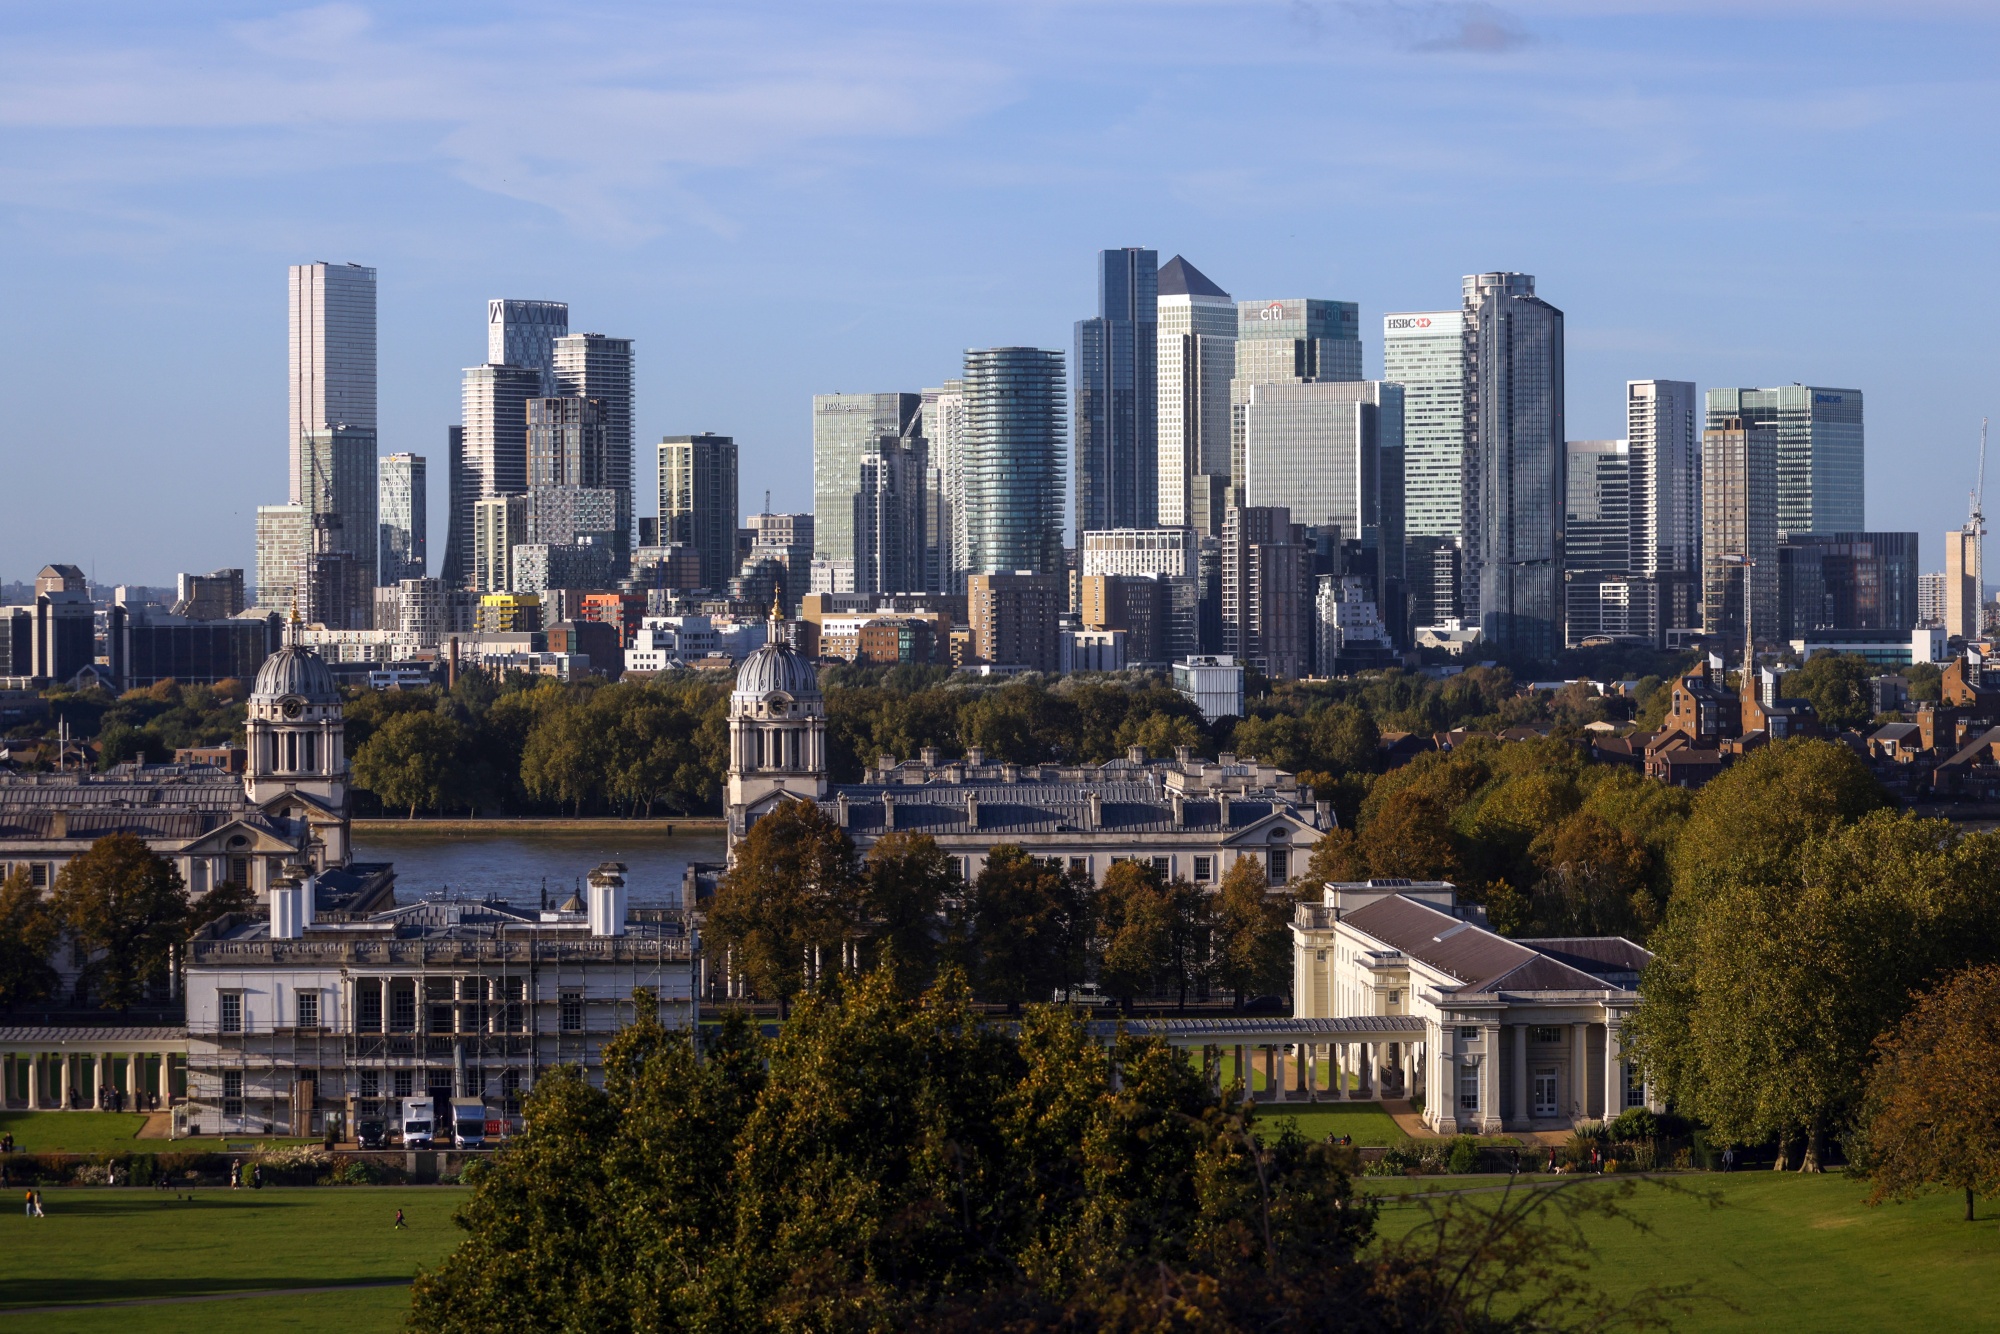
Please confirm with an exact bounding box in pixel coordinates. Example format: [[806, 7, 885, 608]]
[[708, 802, 860, 1014]]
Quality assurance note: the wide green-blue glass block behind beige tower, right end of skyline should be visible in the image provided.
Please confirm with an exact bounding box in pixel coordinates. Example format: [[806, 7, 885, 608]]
[[1708, 384, 1868, 532]]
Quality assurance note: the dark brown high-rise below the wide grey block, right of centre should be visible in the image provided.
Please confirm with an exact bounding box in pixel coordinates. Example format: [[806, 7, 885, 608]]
[[1222, 506, 1312, 680]]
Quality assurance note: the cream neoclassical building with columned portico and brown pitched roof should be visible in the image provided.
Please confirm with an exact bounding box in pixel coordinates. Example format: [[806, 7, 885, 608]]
[[1292, 880, 1652, 1134]]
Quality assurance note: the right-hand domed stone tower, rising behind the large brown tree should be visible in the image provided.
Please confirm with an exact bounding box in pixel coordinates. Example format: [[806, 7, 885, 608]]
[[724, 608, 826, 848]]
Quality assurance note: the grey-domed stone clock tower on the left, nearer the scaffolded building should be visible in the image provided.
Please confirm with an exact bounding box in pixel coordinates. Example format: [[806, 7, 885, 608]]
[[244, 644, 348, 820]]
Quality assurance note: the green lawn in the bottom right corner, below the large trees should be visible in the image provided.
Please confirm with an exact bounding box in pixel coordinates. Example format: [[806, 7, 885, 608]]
[[1366, 1172, 2000, 1334]]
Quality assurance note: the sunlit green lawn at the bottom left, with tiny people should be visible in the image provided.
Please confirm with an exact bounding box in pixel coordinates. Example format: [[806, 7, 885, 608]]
[[0, 1186, 466, 1334]]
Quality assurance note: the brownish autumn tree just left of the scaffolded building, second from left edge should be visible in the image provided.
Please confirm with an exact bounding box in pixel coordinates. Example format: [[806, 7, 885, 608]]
[[54, 834, 188, 1010]]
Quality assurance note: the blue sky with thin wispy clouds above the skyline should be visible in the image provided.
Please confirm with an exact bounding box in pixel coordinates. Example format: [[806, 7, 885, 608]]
[[0, 0, 2000, 582]]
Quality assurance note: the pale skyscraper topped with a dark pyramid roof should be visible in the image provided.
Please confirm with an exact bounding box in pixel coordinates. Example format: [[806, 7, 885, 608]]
[[1156, 254, 1232, 536]]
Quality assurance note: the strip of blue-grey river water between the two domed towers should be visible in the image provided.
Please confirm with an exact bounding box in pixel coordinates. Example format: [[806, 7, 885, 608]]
[[354, 828, 724, 908]]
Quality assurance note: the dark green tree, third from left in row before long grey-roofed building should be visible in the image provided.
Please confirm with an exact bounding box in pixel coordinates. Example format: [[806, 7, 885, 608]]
[[970, 844, 1090, 1012]]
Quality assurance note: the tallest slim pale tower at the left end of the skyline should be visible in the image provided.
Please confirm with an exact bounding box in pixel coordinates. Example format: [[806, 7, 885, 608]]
[[286, 262, 376, 506]]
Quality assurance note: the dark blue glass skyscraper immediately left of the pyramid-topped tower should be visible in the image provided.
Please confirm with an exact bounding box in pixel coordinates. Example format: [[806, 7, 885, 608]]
[[1076, 246, 1160, 540]]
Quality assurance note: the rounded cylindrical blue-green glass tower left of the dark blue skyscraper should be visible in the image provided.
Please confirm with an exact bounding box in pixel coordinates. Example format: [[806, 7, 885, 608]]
[[964, 348, 1066, 574]]
